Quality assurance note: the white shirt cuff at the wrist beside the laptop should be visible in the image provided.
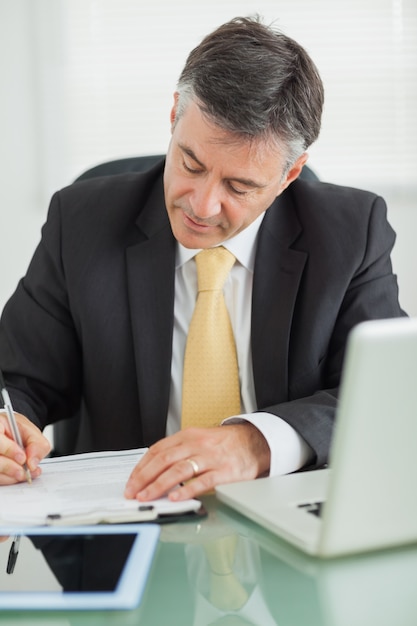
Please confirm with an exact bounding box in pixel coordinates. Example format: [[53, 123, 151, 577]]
[[222, 413, 313, 476]]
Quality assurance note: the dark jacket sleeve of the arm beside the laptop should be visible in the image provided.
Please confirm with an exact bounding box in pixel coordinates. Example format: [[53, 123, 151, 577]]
[[262, 197, 405, 468]]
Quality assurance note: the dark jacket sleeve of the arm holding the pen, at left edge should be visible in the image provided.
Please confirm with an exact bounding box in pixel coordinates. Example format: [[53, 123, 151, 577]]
[[0, 194, 82, 428]]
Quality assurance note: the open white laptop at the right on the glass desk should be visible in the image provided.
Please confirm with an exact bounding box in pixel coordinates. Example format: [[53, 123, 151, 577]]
[[216, 318, 417, 558]]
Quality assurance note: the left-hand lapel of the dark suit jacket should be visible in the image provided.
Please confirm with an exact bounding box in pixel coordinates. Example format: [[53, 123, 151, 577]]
[[126, 179, 175, 443]]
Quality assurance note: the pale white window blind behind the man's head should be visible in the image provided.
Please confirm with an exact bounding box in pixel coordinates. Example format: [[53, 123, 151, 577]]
[[34, 0, 417, 192]]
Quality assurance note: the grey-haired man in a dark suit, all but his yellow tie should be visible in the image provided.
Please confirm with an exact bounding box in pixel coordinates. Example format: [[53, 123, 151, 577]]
[[0, 18, 403, 500]]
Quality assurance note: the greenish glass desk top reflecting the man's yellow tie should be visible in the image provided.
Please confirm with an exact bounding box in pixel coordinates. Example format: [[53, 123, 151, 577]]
[[0, 496, 417, 626]]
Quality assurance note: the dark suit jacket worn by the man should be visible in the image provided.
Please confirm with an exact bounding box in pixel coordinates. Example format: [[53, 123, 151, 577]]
[[0, 158, 402, 466]]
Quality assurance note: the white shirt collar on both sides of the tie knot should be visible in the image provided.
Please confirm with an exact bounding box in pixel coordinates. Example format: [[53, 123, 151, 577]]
[[176, 212, 265, 272]]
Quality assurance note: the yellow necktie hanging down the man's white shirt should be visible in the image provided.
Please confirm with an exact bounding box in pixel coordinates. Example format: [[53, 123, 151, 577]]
[[181, 246, 240, 428]]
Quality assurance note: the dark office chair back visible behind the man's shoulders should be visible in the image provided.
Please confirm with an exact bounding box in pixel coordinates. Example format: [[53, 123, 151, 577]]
[[51, 154, 319, 456]]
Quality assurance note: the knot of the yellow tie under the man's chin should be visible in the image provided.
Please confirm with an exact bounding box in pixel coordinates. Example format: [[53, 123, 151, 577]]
[[195, 246, 236, 291]]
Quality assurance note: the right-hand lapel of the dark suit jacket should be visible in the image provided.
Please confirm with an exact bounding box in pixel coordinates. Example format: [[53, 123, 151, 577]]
[[251, 192, 307, 409]]
